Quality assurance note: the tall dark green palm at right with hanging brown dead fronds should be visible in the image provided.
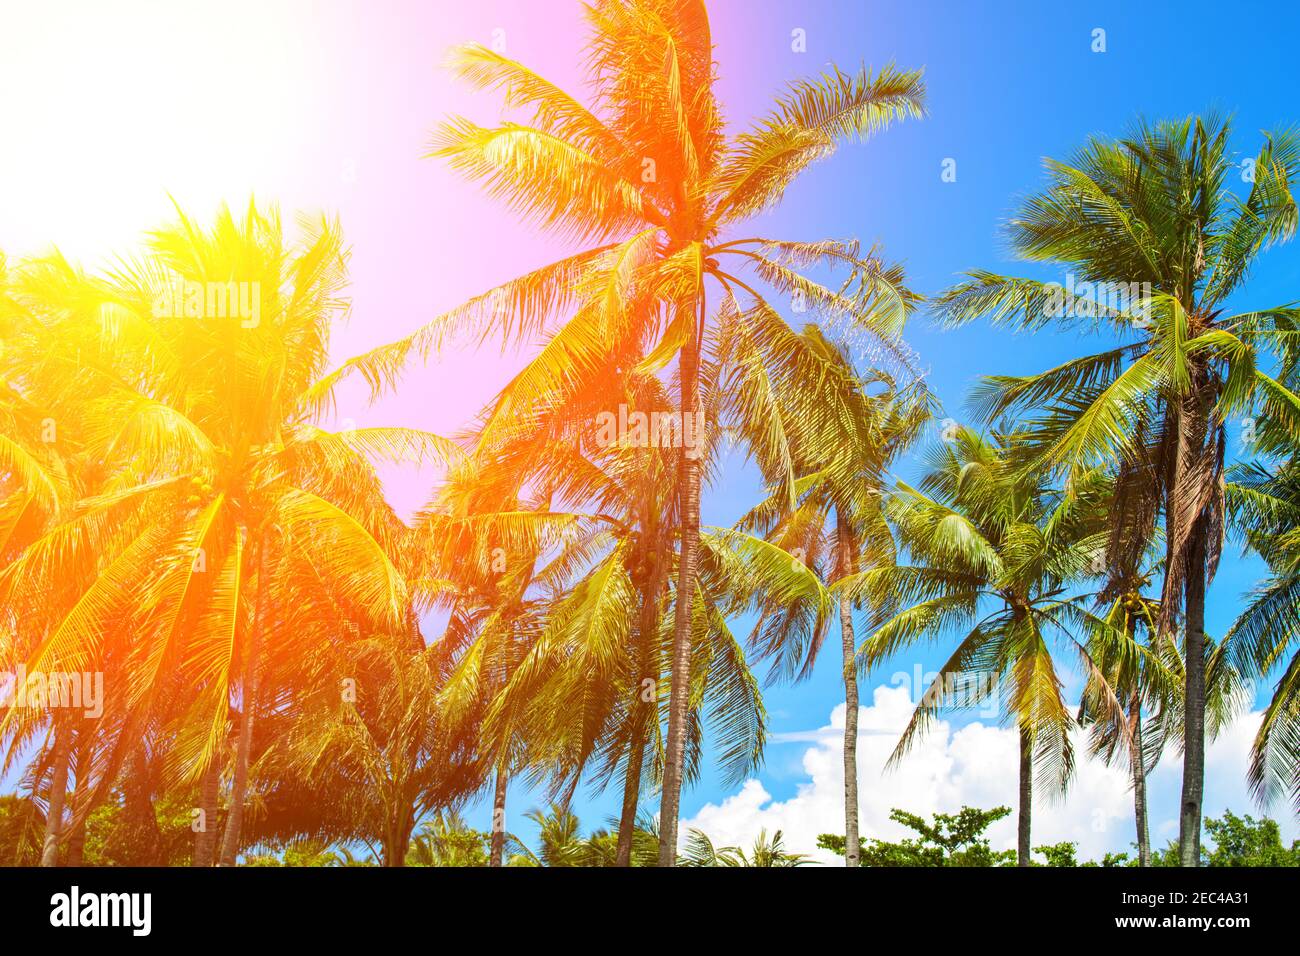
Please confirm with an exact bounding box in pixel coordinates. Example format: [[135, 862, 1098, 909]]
[[939, 117, 1300, 866]]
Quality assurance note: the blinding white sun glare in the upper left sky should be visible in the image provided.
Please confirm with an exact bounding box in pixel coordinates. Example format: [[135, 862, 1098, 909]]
[[0, 0, 329, 265]]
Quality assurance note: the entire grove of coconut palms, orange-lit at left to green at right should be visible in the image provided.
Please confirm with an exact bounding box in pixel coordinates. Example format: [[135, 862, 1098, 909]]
[[0, 0, 1300, 866]]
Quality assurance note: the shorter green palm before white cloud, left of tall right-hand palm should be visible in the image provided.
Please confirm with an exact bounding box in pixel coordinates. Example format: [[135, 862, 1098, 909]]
[[852, 428, 1121, 866]]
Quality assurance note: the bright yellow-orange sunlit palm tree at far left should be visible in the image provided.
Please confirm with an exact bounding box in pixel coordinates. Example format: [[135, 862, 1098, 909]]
[[0, 206, 455, 865]]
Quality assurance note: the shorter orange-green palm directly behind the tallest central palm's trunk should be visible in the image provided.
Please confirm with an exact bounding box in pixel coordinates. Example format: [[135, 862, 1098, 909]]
[[462, 361, 766, 866]]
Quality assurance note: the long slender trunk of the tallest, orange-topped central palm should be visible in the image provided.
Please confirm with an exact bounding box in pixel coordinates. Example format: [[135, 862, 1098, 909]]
[[659, 319, 703, 866]]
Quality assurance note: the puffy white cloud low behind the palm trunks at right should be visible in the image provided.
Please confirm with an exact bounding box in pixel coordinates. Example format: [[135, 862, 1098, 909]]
[[683, 687, 1297, 862]]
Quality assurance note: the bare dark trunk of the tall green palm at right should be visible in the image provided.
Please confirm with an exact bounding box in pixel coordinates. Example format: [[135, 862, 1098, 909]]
[[1178, 515, 1206, 866]]
